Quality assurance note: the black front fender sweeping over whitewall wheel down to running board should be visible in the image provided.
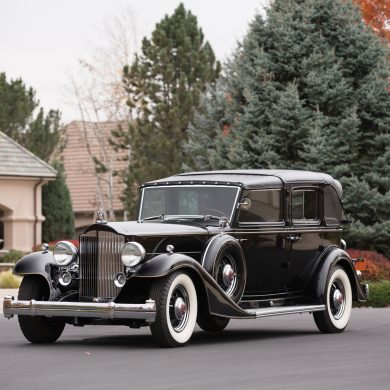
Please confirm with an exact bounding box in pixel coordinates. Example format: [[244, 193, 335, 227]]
[[132, 253, 254, 318]]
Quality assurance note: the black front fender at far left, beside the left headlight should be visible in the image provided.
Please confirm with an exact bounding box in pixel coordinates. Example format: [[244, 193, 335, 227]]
[[13, 251, 57, 294]]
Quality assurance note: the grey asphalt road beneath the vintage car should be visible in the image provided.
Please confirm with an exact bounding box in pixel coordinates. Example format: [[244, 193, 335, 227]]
[[0, 309, 390, 390]]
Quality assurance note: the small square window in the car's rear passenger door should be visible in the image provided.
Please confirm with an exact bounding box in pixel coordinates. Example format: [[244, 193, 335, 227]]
[[291, 189, 319, 222]]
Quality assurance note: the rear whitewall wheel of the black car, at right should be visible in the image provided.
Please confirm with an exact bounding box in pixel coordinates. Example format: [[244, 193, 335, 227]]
[[313, 267, 352, 333]]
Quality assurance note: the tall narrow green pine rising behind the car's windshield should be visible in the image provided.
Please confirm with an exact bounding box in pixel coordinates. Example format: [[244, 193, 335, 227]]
[[115, 4, 220, 215]]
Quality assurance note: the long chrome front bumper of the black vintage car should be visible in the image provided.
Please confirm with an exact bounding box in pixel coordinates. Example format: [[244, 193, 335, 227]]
[[3, 295, 156, 323]]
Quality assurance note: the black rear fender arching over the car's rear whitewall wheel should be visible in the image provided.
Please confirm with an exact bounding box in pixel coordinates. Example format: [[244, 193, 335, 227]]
[[309, 247, 367, 304]]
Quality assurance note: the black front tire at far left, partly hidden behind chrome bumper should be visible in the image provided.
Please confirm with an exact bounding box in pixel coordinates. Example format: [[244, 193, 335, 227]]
[[18, 275, 65, 344]]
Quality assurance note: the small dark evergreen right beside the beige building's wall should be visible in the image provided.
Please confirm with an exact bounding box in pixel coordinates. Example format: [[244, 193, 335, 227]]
[[42, 161, 74, 242]]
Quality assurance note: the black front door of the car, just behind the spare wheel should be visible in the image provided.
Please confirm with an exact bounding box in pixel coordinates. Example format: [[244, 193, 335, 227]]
[[234, 188, 288, 295]]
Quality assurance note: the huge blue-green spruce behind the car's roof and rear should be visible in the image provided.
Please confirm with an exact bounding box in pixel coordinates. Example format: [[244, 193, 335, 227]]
[[188, 0, 390, 254]]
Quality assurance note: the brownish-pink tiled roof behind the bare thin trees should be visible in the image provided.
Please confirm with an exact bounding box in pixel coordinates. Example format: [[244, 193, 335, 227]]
[[62, 121, 126, 212]]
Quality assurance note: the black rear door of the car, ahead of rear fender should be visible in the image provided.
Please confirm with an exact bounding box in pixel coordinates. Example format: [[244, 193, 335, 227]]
[[285, 185, 323, 290]]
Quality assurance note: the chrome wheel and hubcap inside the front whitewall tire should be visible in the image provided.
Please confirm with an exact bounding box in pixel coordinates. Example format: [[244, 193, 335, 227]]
[[169, 286, 190, 333]]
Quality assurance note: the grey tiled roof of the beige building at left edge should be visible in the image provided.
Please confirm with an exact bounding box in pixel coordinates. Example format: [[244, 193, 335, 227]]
[[0, 131, 57, 178]]
